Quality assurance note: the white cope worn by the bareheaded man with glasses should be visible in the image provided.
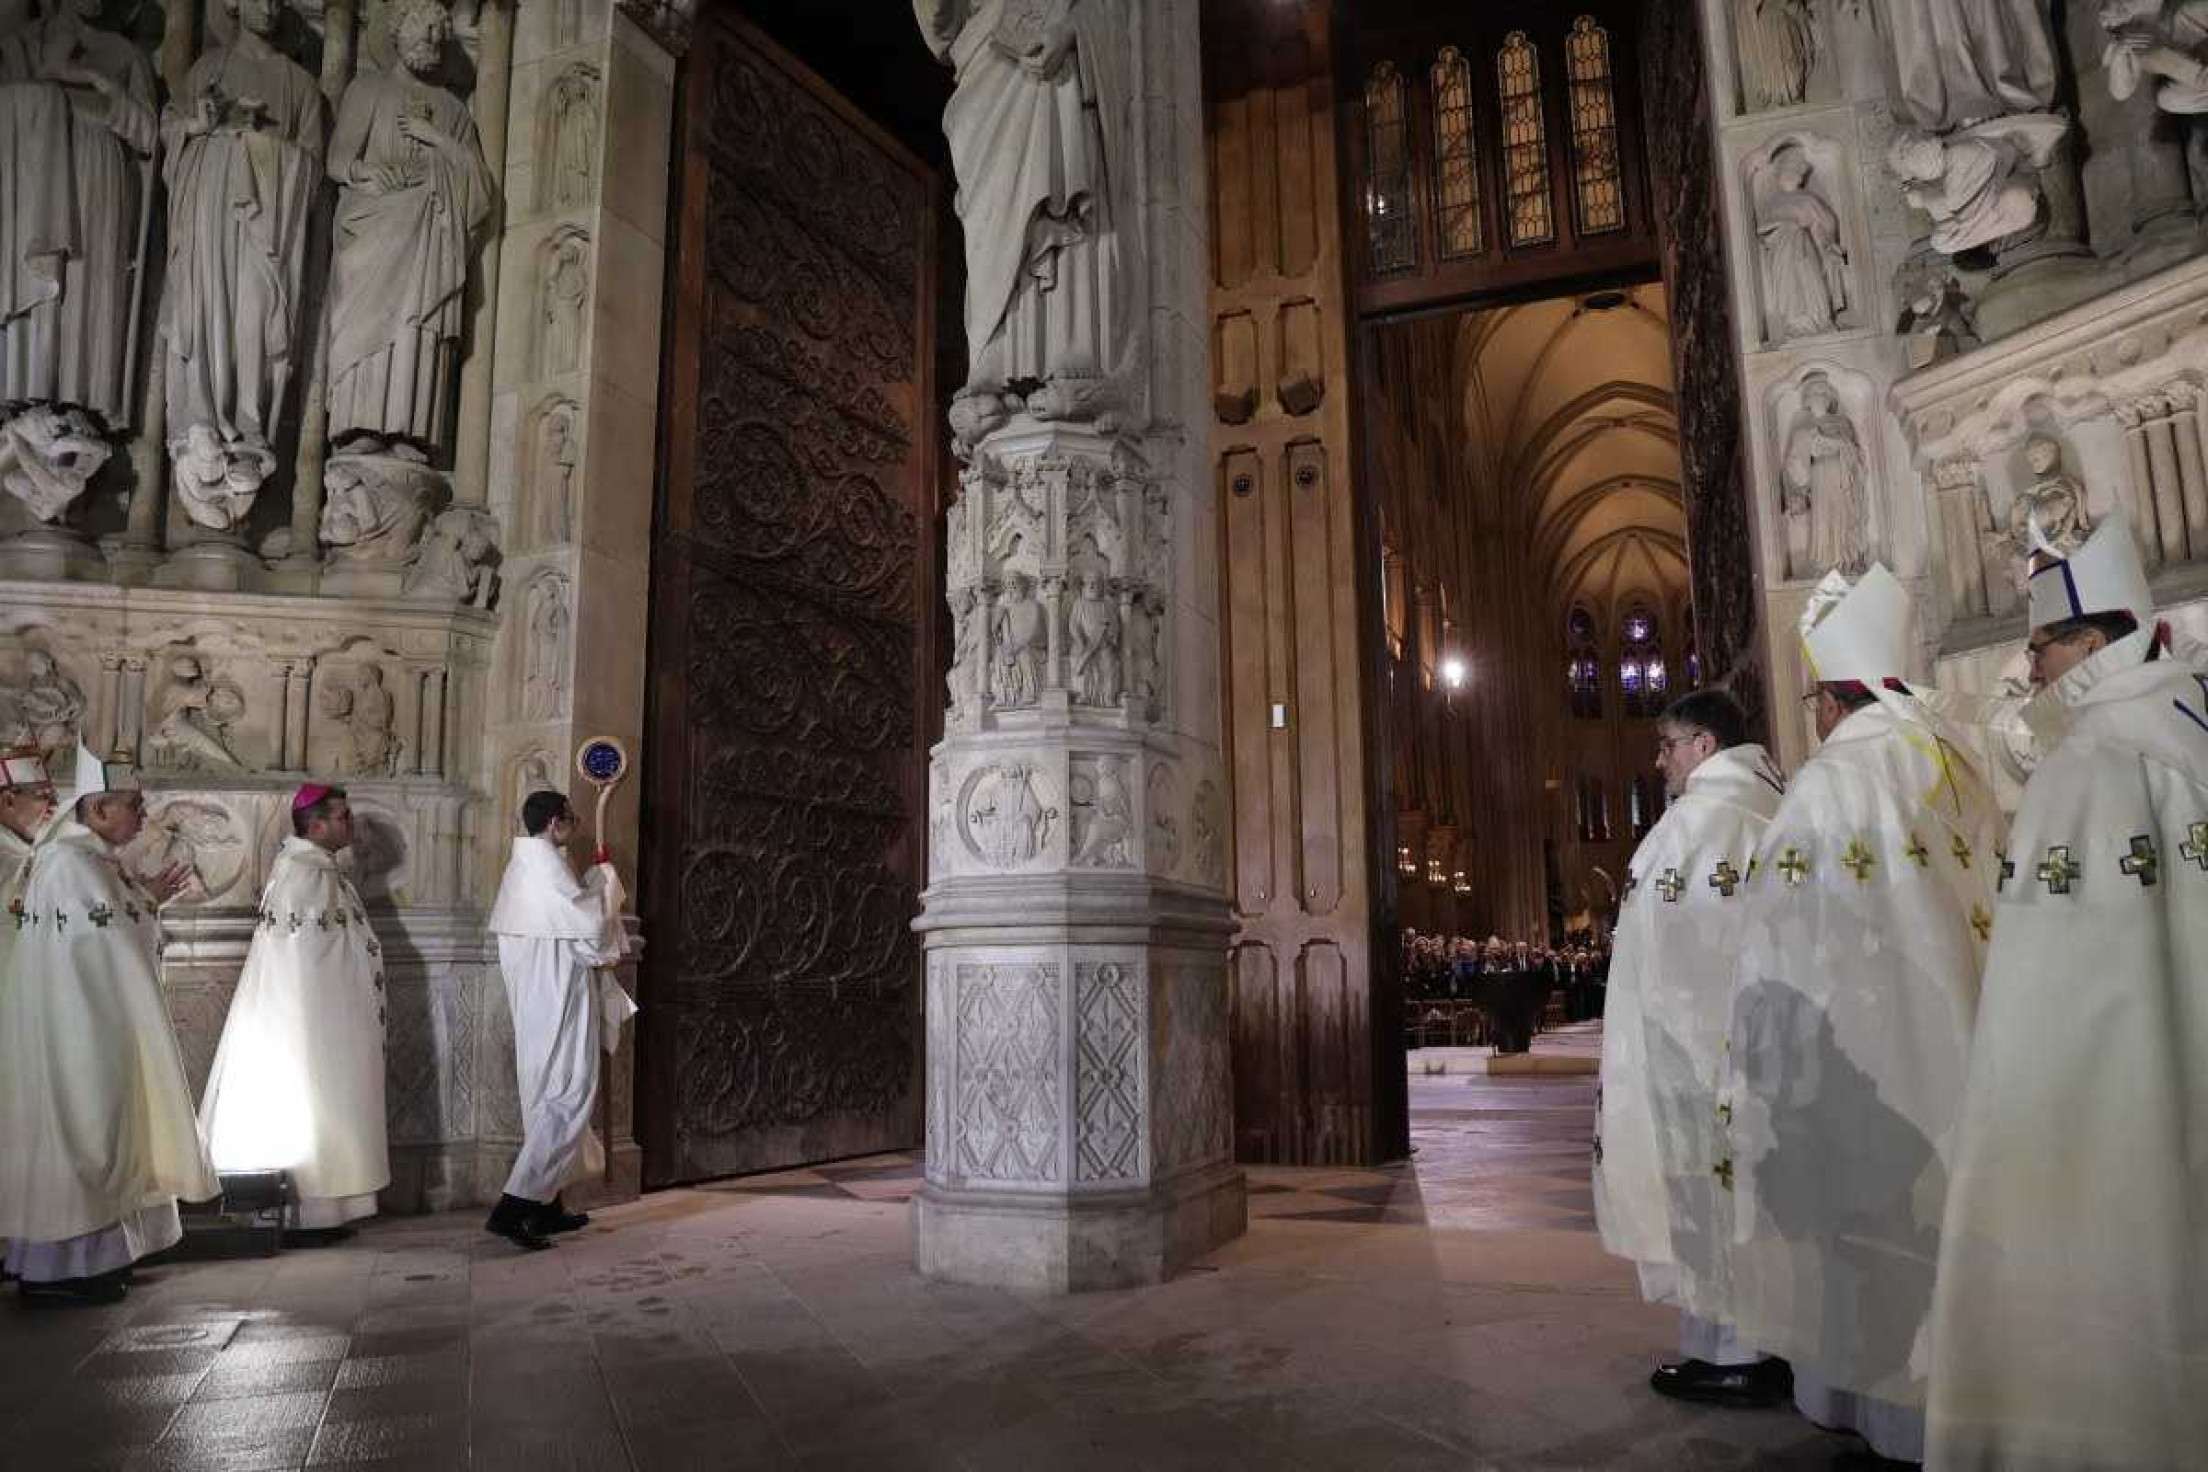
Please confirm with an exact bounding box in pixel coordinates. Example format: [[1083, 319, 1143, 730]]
[[1594, 744, 1784, 1322]]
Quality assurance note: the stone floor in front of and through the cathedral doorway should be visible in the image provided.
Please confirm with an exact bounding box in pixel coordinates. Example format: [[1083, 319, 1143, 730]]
[[0, 1077, 1853, 1472]]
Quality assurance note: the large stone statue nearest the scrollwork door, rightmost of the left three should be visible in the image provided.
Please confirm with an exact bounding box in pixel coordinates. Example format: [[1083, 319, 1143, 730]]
[[329, 0, 495, 448]]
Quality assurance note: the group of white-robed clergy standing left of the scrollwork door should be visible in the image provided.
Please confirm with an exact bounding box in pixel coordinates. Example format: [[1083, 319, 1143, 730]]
[[0, 772, 636, 1304]]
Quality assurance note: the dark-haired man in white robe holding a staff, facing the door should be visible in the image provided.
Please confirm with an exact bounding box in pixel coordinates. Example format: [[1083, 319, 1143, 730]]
[[486, 792, 631, 1249]]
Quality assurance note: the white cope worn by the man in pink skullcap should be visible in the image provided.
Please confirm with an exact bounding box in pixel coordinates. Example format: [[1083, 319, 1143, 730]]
[[199, 839, 391, 1227]]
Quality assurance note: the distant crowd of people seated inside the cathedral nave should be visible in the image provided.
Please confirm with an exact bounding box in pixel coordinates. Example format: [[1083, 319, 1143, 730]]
[[1402, 929, 1610, 1053]]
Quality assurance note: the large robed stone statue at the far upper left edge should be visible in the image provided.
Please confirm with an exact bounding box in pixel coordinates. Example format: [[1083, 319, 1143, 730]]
[[0, 0, 159, 430]]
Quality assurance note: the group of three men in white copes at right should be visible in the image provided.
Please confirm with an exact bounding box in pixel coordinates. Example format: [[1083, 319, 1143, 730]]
[[1594, 514, 2208, 1470]]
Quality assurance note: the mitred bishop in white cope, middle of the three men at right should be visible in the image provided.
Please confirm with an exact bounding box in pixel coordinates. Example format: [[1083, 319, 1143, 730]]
[[1718, 565, 2007, 1461]]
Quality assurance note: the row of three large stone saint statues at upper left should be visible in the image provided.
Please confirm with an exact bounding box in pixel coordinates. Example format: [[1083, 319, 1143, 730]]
[[0, 0, 497, 547]]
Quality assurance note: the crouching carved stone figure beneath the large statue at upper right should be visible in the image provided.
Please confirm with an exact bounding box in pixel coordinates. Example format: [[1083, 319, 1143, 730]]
[[1886, 113, 2069, 256]]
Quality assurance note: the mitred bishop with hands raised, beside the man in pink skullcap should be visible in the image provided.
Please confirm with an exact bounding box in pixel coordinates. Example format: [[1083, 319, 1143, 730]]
[[0, 750, 219, 1302]]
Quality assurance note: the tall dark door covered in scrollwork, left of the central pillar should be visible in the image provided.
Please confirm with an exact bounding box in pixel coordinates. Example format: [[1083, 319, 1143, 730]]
[[644, 7, 941, 1185]]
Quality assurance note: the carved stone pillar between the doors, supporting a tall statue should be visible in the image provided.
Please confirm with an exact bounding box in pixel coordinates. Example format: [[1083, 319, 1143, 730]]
[[914, 0, 1245, 1291]]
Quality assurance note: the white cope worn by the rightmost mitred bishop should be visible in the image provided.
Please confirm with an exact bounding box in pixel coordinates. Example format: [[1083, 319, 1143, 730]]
[[1928, 633, 2208, 1472]]
